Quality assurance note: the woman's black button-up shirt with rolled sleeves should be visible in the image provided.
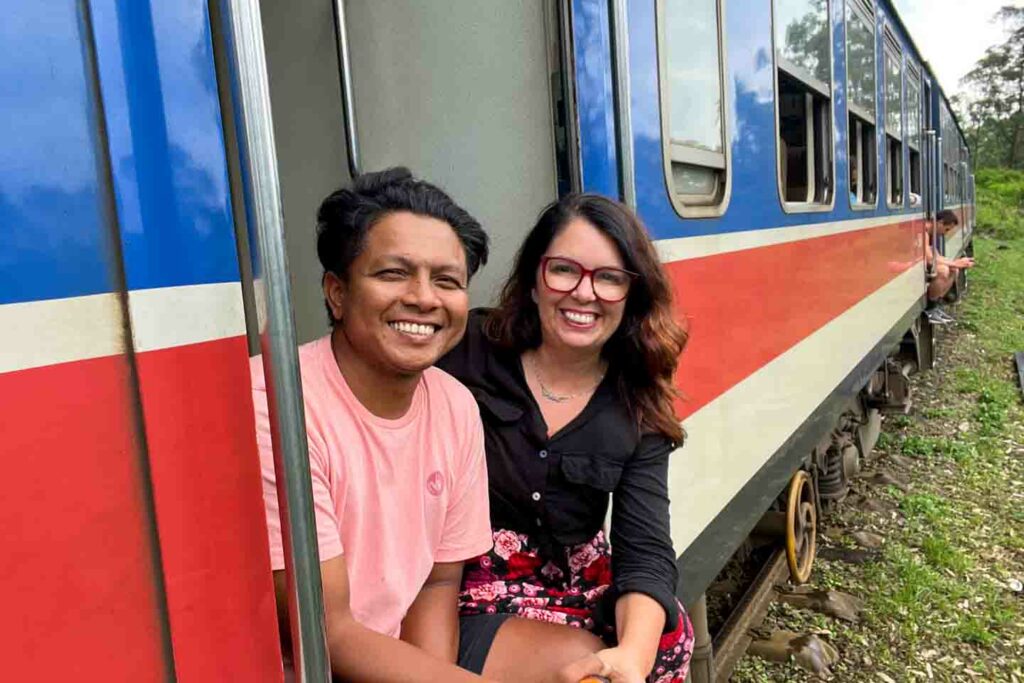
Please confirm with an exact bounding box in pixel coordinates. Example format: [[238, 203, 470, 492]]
[[437, 309, 678, 631]]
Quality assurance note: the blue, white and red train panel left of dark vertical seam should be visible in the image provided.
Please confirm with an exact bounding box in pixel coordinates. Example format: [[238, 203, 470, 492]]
[[0, 2, 174, 681]]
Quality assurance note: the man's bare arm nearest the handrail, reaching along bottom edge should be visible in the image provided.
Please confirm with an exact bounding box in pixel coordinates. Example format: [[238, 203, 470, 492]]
[[273, 555, 481, 683]]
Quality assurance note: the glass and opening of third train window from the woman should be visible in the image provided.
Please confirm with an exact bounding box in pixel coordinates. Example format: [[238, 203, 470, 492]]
[[846, 0, 879, 208]]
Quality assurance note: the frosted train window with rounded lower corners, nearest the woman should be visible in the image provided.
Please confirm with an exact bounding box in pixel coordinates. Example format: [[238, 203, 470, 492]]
[[658, 0, 729, 217]]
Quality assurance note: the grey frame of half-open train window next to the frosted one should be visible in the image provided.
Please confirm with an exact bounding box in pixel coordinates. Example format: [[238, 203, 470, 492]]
[[770, 0, 844, 214]]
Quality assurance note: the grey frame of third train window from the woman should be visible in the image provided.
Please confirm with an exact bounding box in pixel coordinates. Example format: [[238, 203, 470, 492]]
[[843, 0, 881, 211]]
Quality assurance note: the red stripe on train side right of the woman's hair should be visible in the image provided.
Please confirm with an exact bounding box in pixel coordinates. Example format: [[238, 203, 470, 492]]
[[666, 220, 924, 418]]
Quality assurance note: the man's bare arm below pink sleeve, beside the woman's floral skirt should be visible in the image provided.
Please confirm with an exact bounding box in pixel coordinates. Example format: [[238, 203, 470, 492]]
[[401, 562, 463, 663]]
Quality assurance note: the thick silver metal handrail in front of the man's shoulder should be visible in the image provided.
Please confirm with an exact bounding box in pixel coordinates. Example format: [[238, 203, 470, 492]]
[[219, 0, 331, 683]]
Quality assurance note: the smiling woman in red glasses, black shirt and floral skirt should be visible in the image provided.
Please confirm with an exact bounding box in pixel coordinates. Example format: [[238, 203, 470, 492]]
[[440, 195, 693, 683]]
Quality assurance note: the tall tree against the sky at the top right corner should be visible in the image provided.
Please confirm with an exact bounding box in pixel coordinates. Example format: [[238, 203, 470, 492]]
[[961, 5, 1024, 169]]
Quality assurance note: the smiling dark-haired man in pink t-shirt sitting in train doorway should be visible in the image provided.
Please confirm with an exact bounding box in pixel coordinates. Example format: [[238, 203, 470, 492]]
[[252, 169, 492, 681]]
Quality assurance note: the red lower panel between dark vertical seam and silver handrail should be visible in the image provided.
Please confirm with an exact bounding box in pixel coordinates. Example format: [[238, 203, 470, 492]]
[[138, 337, 282, 681]]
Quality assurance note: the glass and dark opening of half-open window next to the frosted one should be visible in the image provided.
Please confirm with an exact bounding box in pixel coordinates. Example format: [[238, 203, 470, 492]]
[[773, 0, 833, 204]]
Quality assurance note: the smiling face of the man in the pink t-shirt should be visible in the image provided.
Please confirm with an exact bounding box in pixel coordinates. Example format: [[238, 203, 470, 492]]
[[324, 211, 469, 376]]
